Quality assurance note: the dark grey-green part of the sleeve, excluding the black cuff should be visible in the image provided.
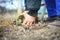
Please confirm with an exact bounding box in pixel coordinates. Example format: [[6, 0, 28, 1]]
[[25, 0, 41, 10]]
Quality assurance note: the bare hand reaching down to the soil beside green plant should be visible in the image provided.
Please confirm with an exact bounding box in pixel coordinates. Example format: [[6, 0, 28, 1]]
[[23, 11, 36, 26]]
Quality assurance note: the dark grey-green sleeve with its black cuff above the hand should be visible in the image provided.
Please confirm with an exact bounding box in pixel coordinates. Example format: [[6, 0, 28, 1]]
[[25, 0, 41, 17]]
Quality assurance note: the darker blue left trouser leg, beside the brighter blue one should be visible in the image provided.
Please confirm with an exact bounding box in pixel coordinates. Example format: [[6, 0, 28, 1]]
[[45, 0, 57, 17]]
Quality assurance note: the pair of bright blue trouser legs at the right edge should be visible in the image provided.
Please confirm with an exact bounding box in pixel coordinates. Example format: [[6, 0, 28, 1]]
[[45, 0, 60, 17]]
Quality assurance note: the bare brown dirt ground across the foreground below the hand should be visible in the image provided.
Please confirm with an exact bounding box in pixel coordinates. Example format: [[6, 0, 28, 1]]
[[0, 12, 60, 40]]
